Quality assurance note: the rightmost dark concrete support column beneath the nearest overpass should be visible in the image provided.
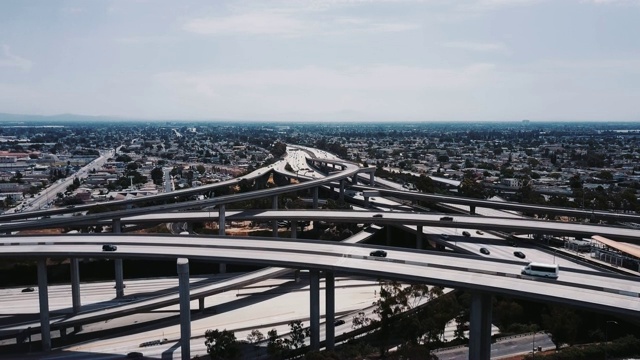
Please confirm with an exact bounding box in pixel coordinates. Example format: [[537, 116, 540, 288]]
[[469, 292, 492, 360]]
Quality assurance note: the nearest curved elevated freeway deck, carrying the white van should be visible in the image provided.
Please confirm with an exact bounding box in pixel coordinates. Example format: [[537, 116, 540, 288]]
[[0, 235, 640, 316]]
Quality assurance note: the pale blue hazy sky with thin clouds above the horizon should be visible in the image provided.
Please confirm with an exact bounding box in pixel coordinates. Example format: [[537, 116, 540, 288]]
[[0, 0, 640, 122]]
